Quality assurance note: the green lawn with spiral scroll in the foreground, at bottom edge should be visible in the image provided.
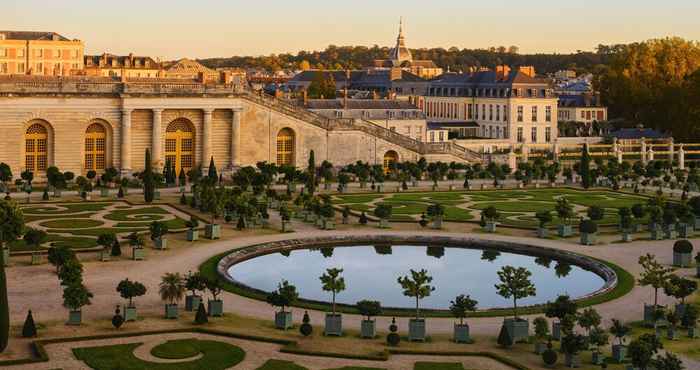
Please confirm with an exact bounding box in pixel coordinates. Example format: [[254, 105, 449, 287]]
[[73, 339, 245, 370]]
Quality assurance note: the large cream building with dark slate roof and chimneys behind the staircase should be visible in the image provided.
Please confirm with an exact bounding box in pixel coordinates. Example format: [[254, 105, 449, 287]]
[[417, 66, 558, 144]]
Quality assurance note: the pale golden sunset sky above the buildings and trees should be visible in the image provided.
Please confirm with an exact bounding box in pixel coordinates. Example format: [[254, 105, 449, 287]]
[[6, 0, 700, 59]]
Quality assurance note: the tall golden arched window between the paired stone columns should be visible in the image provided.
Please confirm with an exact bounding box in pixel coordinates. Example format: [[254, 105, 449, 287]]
[[165, 118, 194, 174]]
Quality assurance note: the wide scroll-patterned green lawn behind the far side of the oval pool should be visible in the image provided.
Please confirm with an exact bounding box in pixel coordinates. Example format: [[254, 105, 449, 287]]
[[333, 188, 648, 228]]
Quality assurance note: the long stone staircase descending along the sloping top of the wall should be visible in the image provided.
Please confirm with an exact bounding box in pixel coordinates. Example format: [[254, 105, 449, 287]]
[[239, 90, 483, 162]]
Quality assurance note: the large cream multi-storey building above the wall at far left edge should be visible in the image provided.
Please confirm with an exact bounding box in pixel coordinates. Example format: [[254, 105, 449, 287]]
[[0, 31, 84, 76]]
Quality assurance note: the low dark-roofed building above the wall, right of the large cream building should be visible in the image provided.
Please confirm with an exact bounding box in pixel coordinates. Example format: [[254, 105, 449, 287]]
[[81, 53, 162, 78]]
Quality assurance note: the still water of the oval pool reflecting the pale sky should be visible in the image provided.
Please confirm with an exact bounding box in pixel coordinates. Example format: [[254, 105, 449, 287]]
[[228, 245, 605, 309]]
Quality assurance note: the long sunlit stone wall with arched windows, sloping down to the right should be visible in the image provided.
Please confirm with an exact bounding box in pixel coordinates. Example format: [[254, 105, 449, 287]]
[[0, 76, 480, 179]]
